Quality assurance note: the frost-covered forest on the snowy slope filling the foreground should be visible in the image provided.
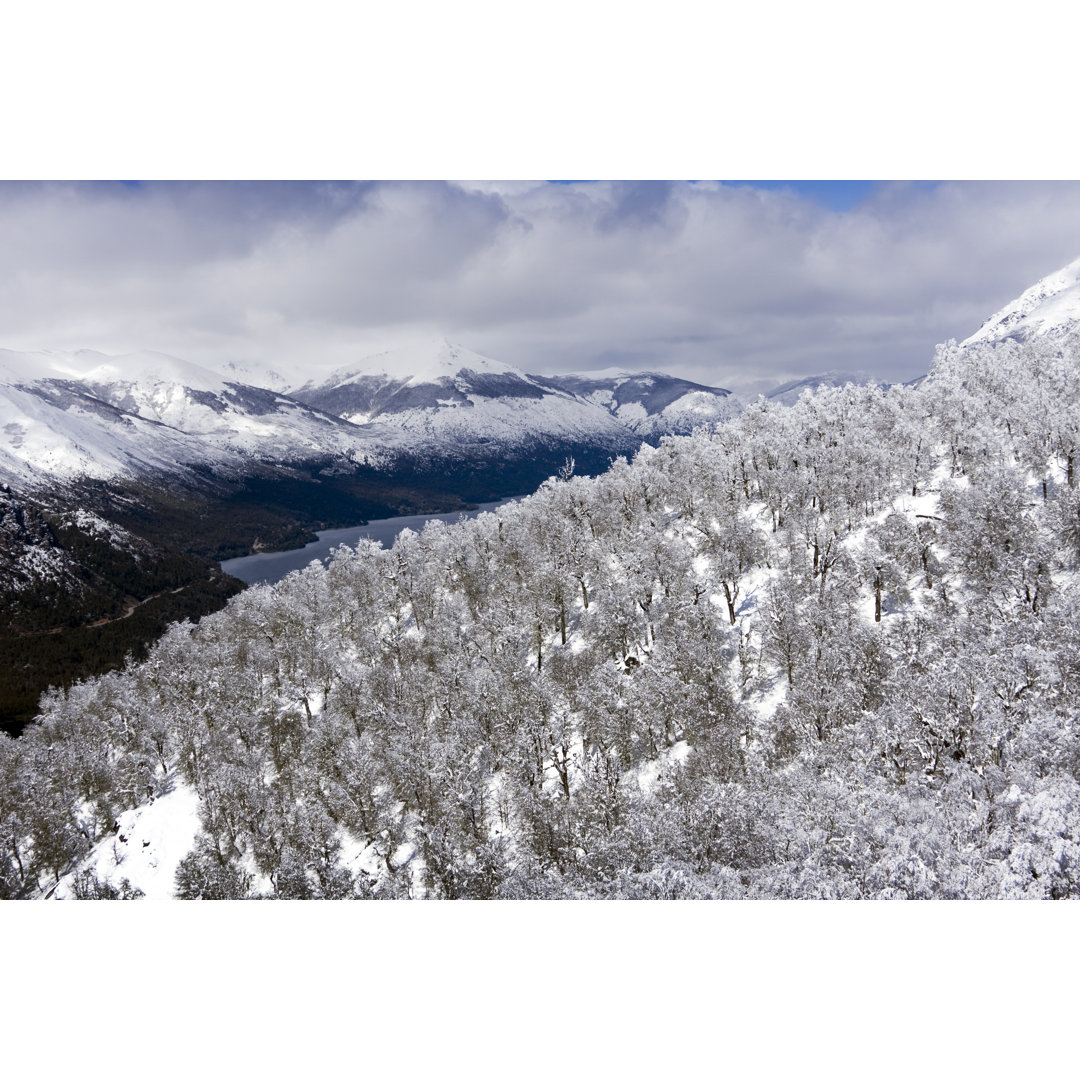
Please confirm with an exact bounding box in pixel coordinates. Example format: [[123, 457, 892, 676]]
[[0, 332, 1080, 899]]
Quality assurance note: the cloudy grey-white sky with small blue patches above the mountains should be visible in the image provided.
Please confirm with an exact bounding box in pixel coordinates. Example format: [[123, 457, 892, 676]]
[[0, 181, 1080, 392]]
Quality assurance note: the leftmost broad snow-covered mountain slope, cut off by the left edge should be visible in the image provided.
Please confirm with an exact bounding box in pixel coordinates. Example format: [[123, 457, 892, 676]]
[[0, 350, 407, 487]]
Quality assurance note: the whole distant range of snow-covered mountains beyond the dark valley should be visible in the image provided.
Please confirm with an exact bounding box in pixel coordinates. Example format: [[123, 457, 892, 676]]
[[0, 340, 738, 489]]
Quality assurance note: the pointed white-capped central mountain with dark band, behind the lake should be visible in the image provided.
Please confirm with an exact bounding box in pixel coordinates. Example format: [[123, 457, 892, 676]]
[[291, 340, 640, 456]]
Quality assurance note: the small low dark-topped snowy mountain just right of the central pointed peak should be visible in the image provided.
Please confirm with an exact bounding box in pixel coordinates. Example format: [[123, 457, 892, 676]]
[[532, 368, 741, 438]]
